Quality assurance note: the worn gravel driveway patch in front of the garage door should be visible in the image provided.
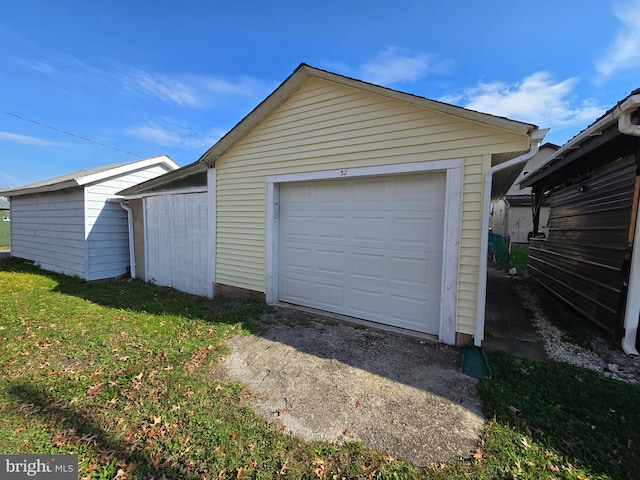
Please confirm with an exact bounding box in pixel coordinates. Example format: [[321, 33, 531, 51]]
[[216, 310, 485, 465]]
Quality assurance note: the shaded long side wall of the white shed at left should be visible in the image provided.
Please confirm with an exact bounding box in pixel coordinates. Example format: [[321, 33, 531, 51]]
[[11, 188, 86, 278]]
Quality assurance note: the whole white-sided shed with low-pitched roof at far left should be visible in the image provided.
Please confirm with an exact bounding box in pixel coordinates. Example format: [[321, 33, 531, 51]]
[[0, 156, 178, 280]]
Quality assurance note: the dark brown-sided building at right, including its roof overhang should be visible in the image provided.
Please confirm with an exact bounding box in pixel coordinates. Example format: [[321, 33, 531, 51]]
[[520, 89, 640, 355]]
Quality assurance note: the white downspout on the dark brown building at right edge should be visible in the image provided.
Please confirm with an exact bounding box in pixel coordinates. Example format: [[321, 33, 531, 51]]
[[618, 95, 640, 355]]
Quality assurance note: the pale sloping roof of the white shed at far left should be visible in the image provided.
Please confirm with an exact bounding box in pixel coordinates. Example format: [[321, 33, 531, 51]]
[[0, 155, 179, 197]]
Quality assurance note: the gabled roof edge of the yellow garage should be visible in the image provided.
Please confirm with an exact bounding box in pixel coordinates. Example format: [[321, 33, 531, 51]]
[[198, 63, 538, 166]]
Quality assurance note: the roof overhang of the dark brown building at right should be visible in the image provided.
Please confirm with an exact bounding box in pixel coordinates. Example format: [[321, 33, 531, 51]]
[[520, 88, 640, 187]]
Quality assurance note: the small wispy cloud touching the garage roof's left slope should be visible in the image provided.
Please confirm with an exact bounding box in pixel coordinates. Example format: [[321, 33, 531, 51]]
[[124, 121, 225, 149]]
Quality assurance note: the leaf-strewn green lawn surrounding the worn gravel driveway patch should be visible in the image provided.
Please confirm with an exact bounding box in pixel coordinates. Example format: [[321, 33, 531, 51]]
[[0, 259, 640, 480]]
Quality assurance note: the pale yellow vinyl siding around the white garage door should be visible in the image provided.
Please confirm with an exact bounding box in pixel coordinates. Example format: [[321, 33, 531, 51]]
[[215, 77, 528, 333]]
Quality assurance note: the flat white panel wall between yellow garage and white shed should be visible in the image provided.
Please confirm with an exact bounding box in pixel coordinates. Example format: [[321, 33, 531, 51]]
[[145, 193, 209, 297]]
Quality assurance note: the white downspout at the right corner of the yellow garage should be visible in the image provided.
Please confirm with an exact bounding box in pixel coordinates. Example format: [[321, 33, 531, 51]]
[[473, 128, 549, 347]]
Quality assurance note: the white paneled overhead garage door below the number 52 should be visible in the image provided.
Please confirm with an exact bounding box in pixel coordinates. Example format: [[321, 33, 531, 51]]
[[278, 173, 445, 335]]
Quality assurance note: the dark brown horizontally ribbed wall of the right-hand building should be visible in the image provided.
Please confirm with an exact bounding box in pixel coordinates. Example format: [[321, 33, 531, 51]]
[[529, 156, 636, 334]]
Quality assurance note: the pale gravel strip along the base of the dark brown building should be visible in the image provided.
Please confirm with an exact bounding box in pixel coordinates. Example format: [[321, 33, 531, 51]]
[[517, 284, 640, 383]]
